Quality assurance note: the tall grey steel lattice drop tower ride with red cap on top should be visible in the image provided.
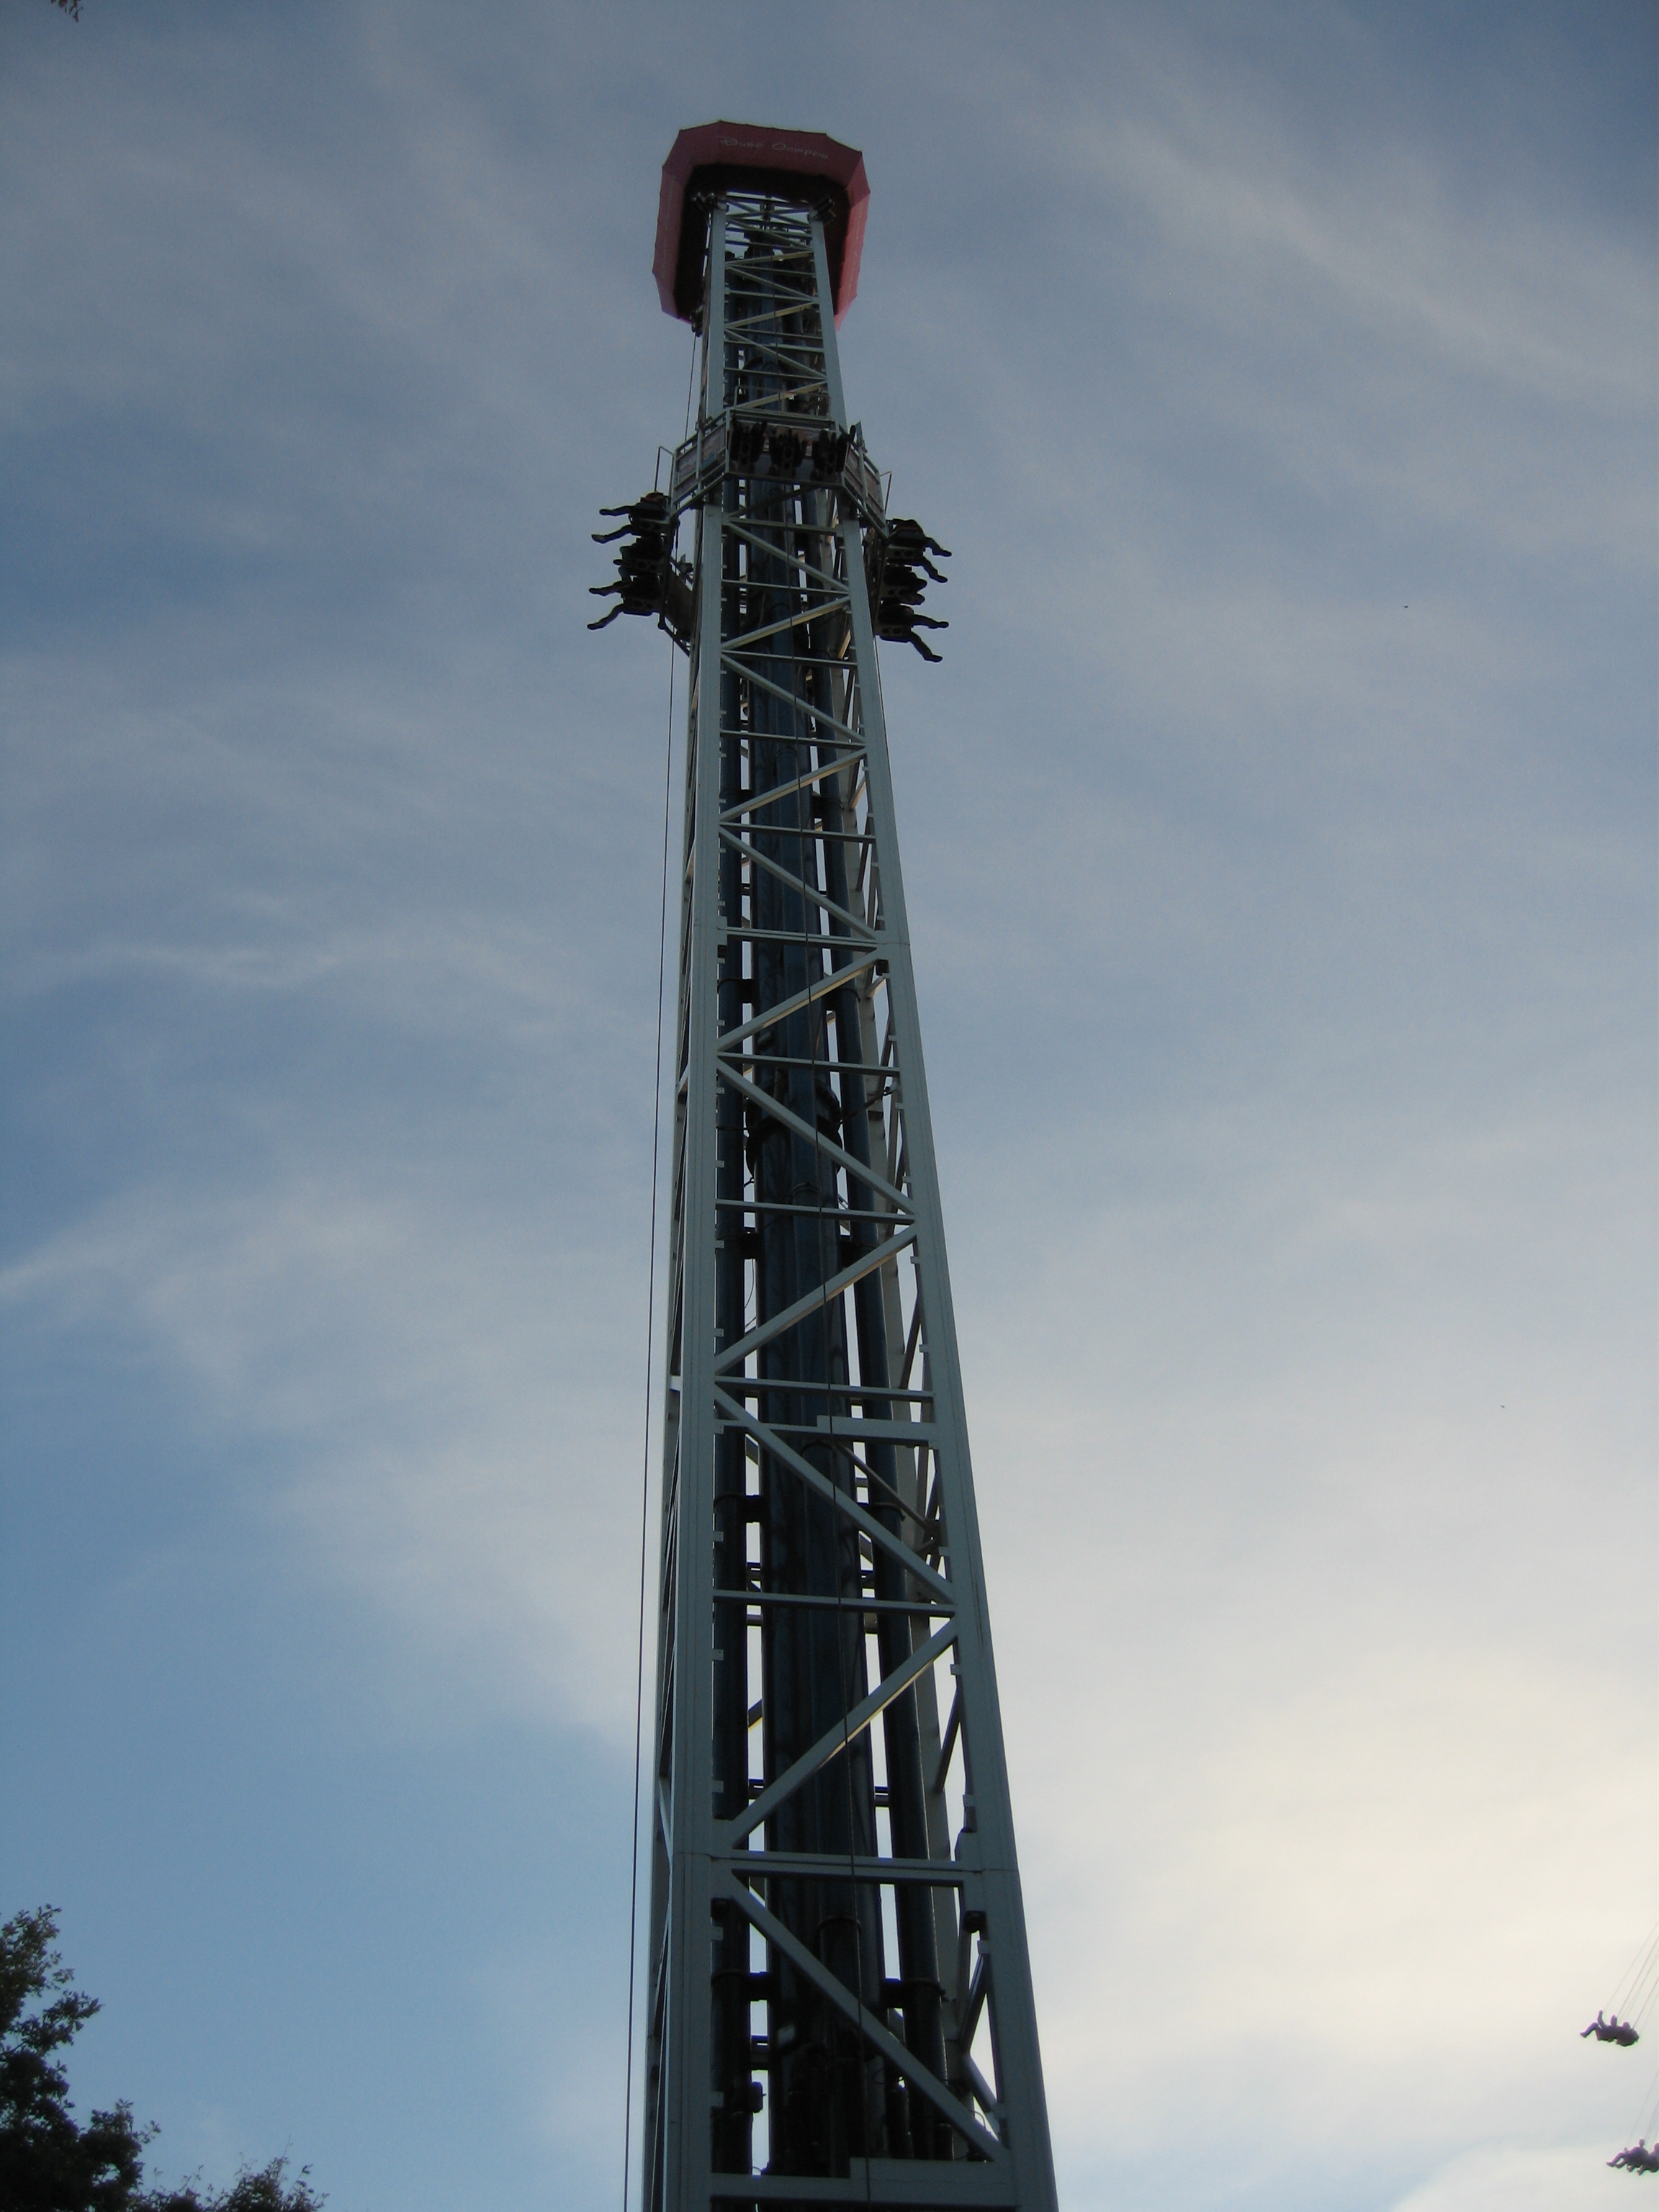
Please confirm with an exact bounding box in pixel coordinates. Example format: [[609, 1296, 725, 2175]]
[[611, 124, 1055, 2212]]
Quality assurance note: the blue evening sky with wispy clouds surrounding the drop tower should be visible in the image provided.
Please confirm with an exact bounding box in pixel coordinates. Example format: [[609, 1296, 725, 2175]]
[[0, 0, 1659, 2212]]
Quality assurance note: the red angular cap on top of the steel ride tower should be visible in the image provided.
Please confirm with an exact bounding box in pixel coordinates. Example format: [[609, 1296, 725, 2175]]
[[650, 124, 869, 323]]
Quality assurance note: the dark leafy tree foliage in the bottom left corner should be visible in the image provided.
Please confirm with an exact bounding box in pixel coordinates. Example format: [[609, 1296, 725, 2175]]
[[0, 1902, 323, 2212]]
